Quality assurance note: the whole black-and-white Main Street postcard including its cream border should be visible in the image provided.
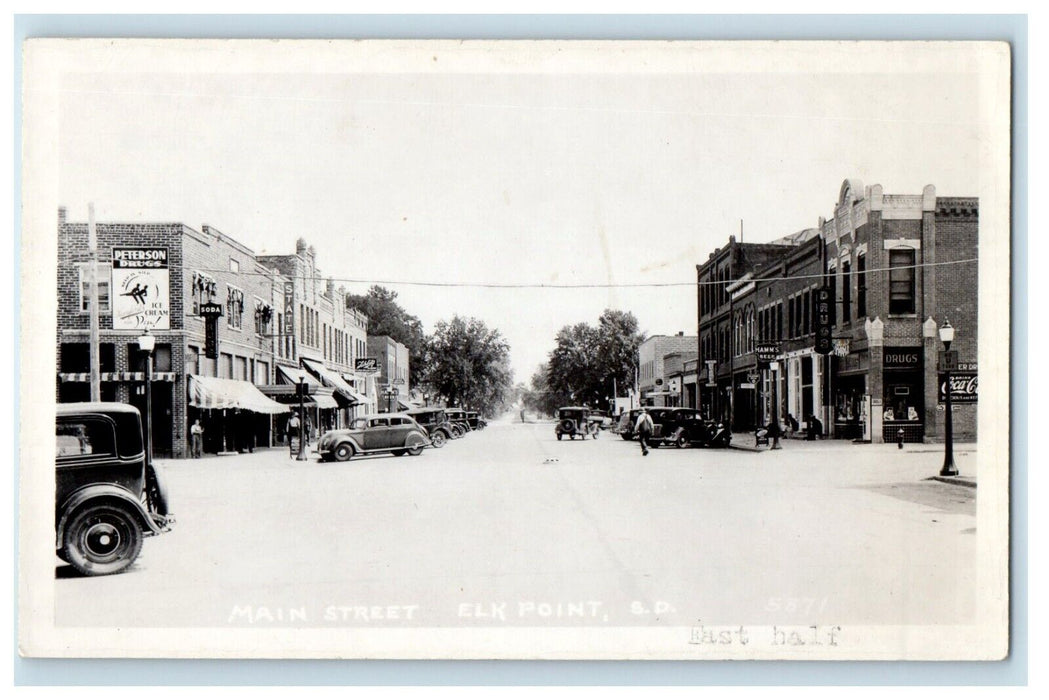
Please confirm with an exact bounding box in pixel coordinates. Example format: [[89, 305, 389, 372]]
[[18, 39, 1012, 660]]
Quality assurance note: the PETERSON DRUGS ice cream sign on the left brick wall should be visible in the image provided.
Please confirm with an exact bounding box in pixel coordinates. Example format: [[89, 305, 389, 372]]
[[109, 248, 171, 331]]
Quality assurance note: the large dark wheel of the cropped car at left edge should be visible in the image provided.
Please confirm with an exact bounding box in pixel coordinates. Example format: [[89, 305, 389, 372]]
[[62, 504, 143, 576]]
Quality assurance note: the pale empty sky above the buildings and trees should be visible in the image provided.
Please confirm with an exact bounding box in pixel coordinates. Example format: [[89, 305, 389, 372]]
[[43, 43, 986, 382]]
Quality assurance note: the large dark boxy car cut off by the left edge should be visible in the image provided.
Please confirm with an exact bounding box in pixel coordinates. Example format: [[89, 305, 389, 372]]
[[55, 402, 174, 576]]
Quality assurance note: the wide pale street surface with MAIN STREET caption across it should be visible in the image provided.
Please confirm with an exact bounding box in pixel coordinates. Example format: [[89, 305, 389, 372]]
[[56, 423, 976, 627]]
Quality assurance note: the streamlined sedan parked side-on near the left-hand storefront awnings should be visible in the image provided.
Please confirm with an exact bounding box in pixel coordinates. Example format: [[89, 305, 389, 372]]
[[317, 413, 431, 462]]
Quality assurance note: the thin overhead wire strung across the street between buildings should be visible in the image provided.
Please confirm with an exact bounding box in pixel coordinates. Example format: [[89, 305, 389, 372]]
[[195, 258, 979, 290]]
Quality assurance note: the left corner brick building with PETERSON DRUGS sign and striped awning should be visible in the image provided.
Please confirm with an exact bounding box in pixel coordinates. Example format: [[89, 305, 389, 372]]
[[57, 209, 285, 457]]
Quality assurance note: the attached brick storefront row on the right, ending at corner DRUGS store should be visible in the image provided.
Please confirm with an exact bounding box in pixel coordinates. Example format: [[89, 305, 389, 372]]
[[698, 181, 979, 442]]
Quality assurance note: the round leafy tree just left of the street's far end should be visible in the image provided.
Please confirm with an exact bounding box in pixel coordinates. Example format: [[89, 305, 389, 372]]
[[423, 316, 513, 416]]
